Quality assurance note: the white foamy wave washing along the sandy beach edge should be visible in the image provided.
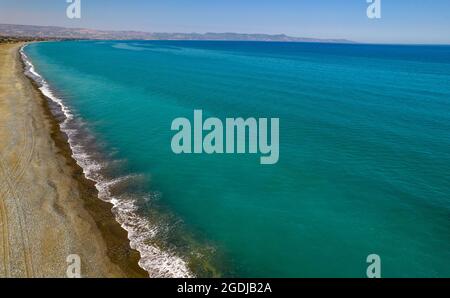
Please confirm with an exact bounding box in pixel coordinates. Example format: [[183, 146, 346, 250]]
[[20, 45, 193, 277]]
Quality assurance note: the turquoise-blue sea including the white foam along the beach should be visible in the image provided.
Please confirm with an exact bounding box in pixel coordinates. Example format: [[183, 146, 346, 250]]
[[24, 41, 450, 277]]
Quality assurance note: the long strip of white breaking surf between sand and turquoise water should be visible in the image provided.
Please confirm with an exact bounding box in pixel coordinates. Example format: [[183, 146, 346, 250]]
[[20, 45, 193, 277]]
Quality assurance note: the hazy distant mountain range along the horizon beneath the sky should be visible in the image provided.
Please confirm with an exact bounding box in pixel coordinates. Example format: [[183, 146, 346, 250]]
[[0, 24, 352, 43]]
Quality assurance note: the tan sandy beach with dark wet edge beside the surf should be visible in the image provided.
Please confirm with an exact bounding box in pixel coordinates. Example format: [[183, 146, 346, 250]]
[[0, 43, 147, 277]]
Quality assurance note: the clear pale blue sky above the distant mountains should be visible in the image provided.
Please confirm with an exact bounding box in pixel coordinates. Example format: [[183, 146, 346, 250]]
[[0, 0, 450, 44]]
